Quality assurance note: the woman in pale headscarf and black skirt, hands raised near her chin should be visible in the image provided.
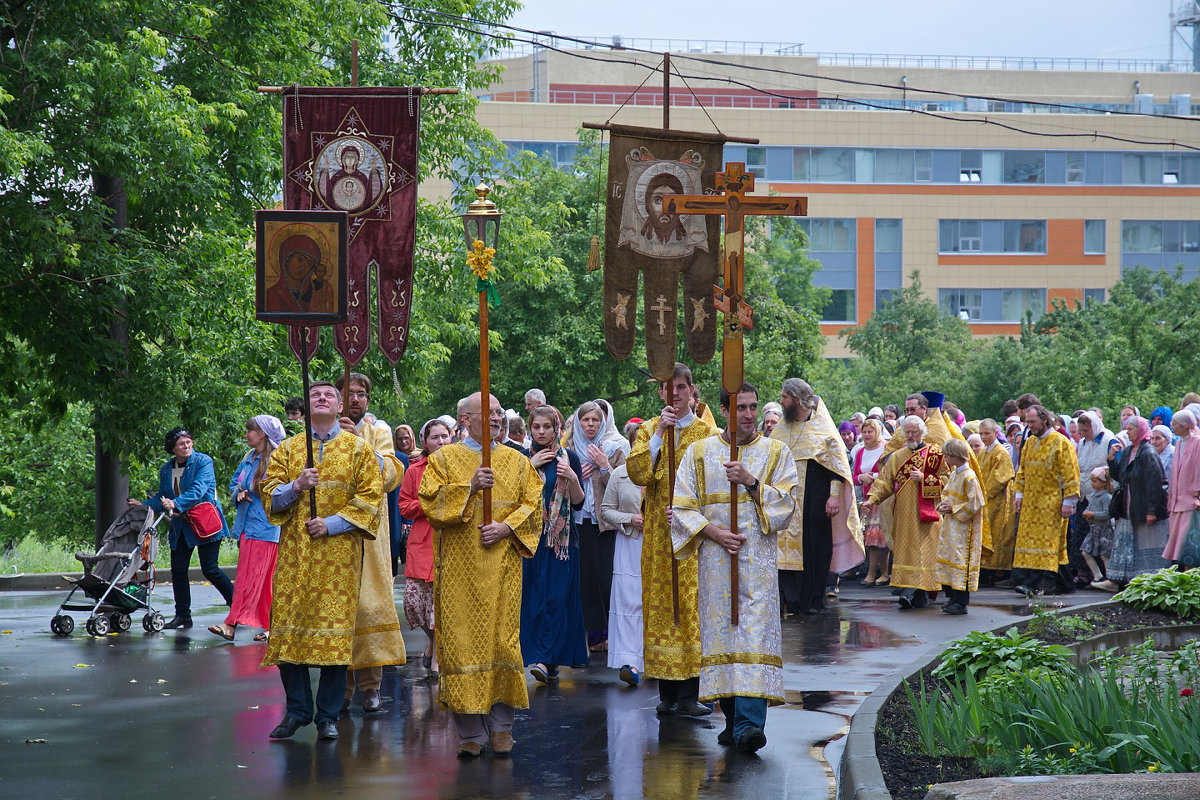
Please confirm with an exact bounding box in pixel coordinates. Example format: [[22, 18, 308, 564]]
[[571, 401, 629, 652]]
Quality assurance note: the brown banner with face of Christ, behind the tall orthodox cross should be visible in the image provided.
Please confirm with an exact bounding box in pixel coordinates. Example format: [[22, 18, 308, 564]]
[[604, 126, 725, 380]]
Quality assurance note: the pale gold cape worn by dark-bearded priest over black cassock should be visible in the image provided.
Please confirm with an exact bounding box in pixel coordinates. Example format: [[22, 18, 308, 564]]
[[770, 397, 866, 572]]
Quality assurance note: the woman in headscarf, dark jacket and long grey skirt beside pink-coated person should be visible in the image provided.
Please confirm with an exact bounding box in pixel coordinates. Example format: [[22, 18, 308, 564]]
[[1109, 416, 1169, 584]]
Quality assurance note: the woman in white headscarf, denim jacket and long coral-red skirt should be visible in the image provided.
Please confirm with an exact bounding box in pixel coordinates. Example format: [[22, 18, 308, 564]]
[[209, 414, 286, 642]]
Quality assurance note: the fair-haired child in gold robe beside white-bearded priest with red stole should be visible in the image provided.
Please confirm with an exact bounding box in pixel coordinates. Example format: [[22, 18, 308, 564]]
[[937, 439, 984, 615]]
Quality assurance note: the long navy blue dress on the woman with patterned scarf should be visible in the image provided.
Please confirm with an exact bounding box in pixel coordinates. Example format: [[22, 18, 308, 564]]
[[521, 450, 588, 668]]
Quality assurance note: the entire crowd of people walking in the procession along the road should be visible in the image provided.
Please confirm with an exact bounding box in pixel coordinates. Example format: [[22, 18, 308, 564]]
[[131, 371, 1200, 758]]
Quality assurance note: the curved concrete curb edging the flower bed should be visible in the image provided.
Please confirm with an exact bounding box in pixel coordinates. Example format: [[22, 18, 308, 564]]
[[838, 600, 1112, 800]]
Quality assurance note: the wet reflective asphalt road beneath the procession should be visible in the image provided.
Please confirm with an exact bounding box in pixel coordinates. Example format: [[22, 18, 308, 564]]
[[0, 584, 1099, 800]]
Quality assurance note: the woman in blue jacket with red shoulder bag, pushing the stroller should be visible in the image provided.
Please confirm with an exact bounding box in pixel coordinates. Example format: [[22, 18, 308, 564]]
[[130, 428, 233, 628]]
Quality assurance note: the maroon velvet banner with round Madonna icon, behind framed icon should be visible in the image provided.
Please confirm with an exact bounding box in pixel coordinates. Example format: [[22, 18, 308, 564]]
[[283, 86, 421, 365]]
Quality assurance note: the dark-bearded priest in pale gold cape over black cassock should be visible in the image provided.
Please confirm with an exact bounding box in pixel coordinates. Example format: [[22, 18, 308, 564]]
[[770, 378, 864, 614]]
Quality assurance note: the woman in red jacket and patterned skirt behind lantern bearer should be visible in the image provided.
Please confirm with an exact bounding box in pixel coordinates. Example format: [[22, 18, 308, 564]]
[[396, 417, 454, 678]]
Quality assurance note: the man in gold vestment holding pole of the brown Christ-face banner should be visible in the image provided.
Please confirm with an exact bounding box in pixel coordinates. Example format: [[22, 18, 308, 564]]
[[625, 363, 718, 716]]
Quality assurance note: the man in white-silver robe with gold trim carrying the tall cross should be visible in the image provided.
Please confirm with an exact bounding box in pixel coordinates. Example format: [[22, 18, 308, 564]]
[[671, 384, 797, 753]]
